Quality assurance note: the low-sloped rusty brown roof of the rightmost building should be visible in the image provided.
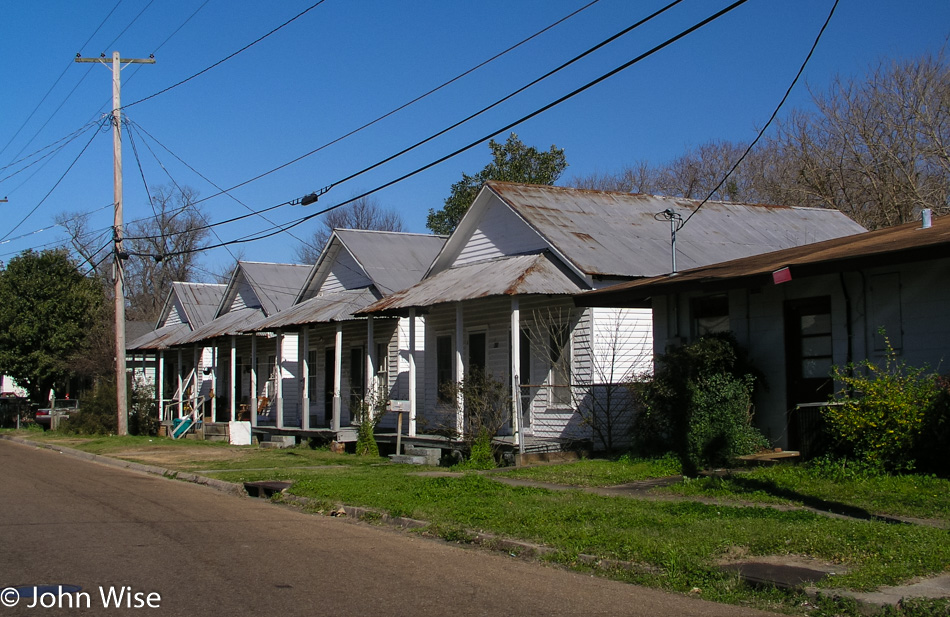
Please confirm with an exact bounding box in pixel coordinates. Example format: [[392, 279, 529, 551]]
[[575, 216, 950, 306]]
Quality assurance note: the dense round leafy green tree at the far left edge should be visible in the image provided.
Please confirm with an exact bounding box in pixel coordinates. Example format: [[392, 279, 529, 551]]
[[0, 250, 103, 404]]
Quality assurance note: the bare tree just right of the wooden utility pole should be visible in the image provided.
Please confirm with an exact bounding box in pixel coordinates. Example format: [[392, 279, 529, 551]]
[[125, 186, 208, 320]]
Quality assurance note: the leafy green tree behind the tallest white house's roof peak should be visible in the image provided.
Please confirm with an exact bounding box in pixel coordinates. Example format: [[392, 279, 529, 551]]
[[426, 133, 567, 235]]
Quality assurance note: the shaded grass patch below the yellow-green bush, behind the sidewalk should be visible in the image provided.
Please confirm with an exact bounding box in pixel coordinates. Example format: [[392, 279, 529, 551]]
[[654, 465, 950, 523]]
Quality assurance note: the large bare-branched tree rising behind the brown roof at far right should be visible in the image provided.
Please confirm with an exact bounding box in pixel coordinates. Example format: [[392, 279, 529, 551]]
[[769, 54, 950, 229]]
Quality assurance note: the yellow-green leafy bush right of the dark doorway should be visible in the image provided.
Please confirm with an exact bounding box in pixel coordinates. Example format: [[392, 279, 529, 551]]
[[823, 337, 948, 472]]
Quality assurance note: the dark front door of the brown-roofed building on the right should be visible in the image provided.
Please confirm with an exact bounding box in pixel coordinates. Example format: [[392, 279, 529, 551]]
[[785, 296, 834, 450]]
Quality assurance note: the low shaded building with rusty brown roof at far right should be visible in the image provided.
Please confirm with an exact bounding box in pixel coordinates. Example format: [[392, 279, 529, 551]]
[[576, 212, 950, 450]]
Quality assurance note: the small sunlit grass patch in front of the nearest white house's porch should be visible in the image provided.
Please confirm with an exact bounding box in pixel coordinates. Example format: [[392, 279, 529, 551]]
[[499, 456, 682, 487]]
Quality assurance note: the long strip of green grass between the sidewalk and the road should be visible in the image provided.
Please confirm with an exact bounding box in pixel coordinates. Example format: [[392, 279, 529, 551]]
[[208, 466, 950, 594]]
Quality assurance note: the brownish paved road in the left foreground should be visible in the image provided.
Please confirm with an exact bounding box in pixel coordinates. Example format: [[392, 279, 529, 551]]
[[0, 440, 780, 617]]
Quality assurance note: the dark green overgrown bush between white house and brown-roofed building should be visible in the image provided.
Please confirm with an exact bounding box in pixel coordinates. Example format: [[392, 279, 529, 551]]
[[633, 333, 768, 476]]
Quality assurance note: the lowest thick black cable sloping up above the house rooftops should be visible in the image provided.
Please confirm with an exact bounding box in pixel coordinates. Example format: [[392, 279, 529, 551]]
[[139, 0, 748, 257]]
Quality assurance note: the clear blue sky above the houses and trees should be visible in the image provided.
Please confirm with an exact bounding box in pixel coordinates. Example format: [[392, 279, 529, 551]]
[[0, 0, 950, 270]]
